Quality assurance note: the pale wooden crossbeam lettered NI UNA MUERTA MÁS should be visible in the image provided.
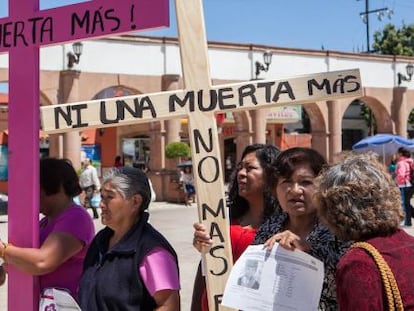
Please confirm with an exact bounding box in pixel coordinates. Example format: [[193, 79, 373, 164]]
[[41, 69, 361, 134]]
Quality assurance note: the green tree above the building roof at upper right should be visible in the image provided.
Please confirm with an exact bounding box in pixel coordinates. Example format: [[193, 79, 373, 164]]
[[373, 24, 414, 56]]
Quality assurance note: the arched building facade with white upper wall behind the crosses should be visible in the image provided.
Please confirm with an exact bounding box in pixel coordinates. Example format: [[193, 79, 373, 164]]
[[0, 36, 414, 200]]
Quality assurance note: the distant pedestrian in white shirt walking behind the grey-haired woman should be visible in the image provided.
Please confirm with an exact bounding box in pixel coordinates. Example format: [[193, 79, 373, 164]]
[[79, 158, 101, 218]]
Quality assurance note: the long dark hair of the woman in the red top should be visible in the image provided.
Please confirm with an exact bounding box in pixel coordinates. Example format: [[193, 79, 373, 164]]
[[227, 144, 280, 219]]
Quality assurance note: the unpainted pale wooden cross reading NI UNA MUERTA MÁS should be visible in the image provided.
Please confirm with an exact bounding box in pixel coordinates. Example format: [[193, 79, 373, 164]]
[[41, 0, 362, 310]]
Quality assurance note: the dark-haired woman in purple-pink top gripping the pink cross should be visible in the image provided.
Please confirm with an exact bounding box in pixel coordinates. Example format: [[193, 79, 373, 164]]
[[0, 158, 95, 298]]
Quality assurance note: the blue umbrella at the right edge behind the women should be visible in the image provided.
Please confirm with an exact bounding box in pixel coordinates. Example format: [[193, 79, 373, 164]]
[[352, 134, 414, 159]]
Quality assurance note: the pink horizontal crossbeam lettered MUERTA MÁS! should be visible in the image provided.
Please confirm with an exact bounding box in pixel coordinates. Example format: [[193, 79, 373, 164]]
[[0, 0, 169, 52]]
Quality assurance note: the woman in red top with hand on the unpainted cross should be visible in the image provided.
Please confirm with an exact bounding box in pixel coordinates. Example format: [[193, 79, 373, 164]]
[[191, 144, 280, 311]]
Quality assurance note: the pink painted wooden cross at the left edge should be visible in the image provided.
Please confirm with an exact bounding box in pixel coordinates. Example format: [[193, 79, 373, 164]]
[[0, 0, 169, 310]]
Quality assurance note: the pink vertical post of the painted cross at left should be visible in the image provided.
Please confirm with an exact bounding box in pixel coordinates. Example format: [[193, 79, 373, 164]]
[[8, 0, 39, 310]]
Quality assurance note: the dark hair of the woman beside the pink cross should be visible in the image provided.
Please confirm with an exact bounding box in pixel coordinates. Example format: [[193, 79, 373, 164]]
[[39, 158, 82, 197]]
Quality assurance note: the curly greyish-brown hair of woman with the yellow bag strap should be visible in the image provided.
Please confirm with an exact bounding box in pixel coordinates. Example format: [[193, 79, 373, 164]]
[[314, 152, 403, 241]]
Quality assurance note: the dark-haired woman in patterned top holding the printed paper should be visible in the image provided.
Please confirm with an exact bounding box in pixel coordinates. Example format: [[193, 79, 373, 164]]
[[254, 147, 349, 310]]
